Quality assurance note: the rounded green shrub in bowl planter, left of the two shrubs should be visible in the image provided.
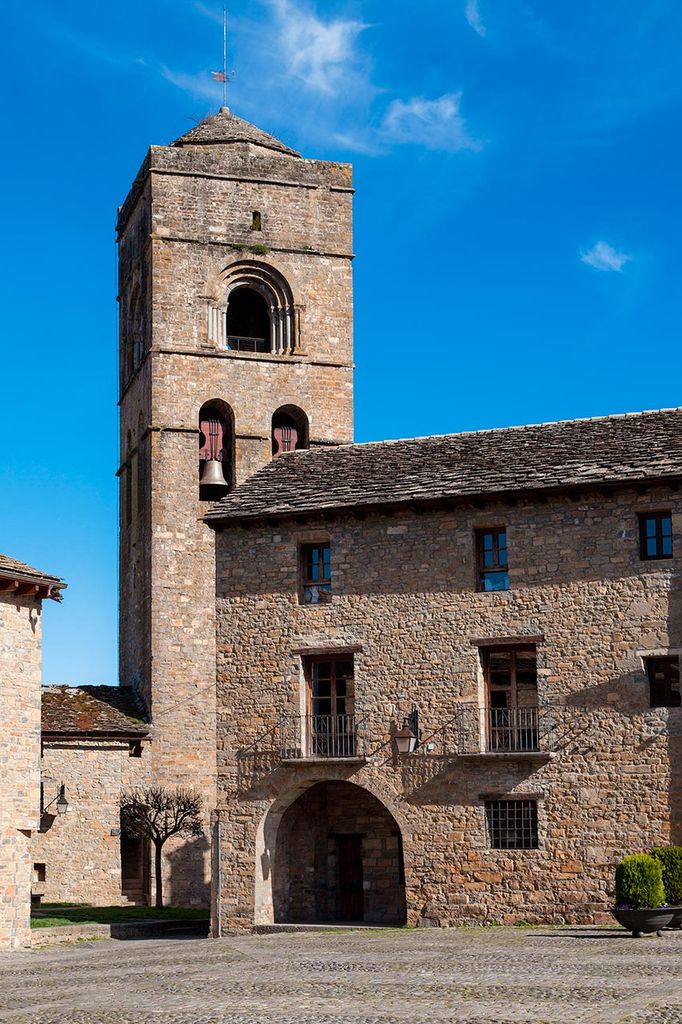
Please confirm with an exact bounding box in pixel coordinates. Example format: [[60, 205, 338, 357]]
[[611, 853, 675, 938]]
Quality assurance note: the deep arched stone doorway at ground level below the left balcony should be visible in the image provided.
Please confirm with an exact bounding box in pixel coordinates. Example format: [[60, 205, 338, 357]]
[[272, 781, 406, 925]]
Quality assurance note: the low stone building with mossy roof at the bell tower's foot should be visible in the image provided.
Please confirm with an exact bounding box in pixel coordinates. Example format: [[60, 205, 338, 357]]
[[32, 686, 151, 906]]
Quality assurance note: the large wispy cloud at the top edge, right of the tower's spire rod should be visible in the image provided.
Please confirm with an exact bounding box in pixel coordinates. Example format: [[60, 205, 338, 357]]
[[270, 0, 370, 94]]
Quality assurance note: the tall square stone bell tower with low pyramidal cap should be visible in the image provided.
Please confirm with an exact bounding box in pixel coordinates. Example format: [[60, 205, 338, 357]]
[[118, 108, 353, 902]]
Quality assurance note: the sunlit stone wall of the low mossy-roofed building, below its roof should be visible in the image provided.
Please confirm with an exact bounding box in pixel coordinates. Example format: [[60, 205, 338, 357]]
[[31, 738, 151, 906]]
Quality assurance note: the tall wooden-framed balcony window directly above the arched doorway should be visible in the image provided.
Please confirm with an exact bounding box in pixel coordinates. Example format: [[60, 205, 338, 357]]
[[304, 655, 356, 758]]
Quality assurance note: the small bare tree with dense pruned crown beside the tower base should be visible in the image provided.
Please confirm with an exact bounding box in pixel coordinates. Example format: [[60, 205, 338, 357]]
[[120, 785, 204, 906]]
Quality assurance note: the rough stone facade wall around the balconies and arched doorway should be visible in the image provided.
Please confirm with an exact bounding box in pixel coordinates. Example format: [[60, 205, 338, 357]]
[[216, 488, 682, 929]]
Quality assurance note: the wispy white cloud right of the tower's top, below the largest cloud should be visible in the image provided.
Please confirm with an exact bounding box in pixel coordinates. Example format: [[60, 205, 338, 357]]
[[381, 92, 482, 153]]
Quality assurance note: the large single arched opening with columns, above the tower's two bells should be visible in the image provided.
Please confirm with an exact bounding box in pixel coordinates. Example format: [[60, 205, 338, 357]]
[[208, 261, 300, 355]]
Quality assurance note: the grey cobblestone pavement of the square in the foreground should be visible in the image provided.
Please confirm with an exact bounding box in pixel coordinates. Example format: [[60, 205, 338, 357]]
[[0, 928, 682, 1024]]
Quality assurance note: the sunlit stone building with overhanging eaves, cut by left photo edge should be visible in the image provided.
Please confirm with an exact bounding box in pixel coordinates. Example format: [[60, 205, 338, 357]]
[[0, 555, 66, 949]]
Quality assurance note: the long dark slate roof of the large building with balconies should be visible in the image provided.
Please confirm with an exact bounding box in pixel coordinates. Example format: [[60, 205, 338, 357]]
[[206, 409, 682, 524]]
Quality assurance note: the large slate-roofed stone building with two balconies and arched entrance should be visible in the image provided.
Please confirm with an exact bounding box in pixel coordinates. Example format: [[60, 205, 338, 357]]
[[207, 410, 682, 930]]
